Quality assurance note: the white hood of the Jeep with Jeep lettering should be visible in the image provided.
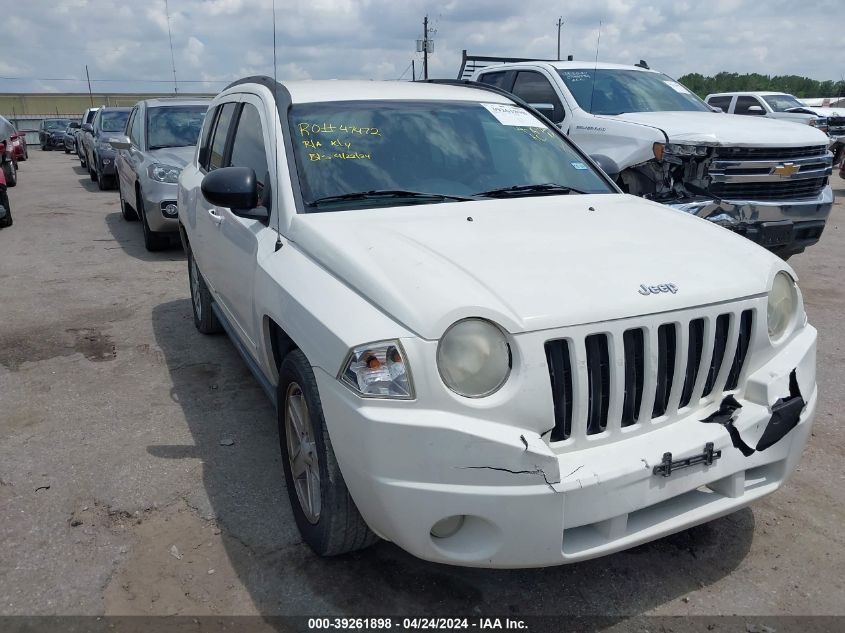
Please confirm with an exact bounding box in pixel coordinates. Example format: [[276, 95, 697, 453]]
[[288, 194, 784, 340]]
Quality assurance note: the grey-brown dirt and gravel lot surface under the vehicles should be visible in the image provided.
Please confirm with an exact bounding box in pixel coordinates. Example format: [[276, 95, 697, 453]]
[[0, 148, 845, 630]]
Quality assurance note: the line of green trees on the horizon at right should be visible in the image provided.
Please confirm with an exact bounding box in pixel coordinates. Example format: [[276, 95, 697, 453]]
[[678, 72, 845, 98]]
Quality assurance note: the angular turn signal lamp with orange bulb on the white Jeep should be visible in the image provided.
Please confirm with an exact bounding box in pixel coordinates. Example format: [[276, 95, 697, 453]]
[[339, 341, 414, 400]]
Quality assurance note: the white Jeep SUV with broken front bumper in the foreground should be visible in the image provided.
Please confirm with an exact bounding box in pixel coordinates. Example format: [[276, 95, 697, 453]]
[[178, 77, 817, 567]]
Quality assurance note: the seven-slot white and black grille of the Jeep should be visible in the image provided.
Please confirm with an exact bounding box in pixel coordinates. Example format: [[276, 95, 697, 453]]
[[545, 309, 754, 442]]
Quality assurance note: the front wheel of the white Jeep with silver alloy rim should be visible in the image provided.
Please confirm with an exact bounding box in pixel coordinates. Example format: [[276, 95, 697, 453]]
[[278, 350, 378, 556]]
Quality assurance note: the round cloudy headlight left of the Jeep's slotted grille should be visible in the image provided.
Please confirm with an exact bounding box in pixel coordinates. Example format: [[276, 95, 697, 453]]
[[437, 319, 511, 398]]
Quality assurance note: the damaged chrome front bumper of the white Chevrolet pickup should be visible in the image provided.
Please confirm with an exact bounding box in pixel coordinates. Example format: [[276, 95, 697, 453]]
[[666, 185, 833, 254]]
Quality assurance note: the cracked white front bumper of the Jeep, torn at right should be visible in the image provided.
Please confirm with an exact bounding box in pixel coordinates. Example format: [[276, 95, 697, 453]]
[[315, 326, 817, 568]]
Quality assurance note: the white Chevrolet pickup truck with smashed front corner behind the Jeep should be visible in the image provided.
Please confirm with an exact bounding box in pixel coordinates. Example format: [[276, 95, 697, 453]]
[[459, 51, 833, 258]]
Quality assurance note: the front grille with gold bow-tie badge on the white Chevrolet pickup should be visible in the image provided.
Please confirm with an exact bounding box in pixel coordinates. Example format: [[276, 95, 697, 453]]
[[708, 145, 833, 200]]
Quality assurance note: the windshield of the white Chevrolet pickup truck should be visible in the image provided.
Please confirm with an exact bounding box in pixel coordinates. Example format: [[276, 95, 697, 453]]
[[558, 68, 712, 115]]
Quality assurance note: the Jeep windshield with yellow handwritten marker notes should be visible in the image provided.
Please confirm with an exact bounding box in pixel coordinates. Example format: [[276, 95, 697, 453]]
[[289, 101, 615, 212]]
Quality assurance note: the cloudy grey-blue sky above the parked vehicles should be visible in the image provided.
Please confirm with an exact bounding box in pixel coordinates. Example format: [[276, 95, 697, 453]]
[[0, 0, 845, 92]]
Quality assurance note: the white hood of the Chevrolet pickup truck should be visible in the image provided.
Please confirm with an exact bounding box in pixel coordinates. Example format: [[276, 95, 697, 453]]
[[597, 112, 828, 147]]
